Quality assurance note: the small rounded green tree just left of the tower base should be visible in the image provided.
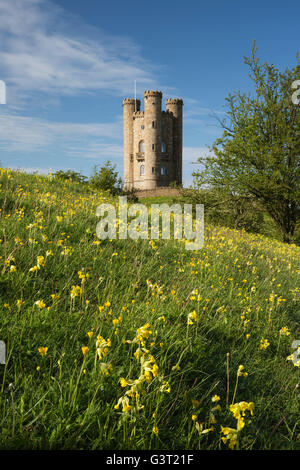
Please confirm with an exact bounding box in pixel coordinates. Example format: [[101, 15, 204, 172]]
[[90, 160, 122, 194]]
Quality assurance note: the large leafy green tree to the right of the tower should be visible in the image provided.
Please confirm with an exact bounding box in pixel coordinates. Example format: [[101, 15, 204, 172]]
[[193, 42, 300, 243]]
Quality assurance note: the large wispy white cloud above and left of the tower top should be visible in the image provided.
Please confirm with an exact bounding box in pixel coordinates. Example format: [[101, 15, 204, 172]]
[[0, 0, 159, 103]]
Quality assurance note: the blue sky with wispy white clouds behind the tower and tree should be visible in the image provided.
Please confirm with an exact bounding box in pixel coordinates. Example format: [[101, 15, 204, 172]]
[[0, 0, 300, 185]]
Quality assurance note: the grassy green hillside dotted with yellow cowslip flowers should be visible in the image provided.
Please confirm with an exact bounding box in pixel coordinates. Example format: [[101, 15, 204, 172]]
[[0, 170, 300, 450]]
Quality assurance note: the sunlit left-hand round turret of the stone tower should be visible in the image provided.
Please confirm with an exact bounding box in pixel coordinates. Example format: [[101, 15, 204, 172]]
[[123, 98, 141, 190]]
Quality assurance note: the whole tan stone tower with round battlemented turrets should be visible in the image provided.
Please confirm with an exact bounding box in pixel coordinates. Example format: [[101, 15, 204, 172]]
[[123, 90, 183, 190]]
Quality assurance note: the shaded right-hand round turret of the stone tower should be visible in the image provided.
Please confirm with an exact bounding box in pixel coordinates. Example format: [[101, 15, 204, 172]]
[[166, 98, 183, 184]]
